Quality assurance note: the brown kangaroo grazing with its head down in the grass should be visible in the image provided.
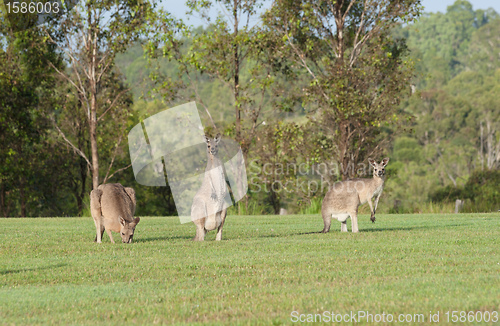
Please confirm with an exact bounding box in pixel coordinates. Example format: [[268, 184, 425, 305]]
[[90, 183, 141, 243]]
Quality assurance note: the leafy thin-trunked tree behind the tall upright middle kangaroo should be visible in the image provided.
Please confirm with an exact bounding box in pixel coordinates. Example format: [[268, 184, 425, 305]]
[[150, 0, 275, 156]]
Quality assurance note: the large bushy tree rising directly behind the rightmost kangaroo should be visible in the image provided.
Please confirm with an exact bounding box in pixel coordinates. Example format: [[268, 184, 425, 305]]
[[263, 0, 421, 179]]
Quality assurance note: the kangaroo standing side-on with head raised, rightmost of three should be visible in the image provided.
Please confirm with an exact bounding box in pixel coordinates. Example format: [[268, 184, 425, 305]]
[[321, 157, 389, 233]]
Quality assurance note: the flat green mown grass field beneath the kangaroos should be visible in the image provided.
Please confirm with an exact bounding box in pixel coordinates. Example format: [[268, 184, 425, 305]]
[[0, 213, 500, 325]]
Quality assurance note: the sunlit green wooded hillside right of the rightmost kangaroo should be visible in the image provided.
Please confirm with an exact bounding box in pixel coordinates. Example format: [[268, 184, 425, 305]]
[[383, 0, 500, 212]]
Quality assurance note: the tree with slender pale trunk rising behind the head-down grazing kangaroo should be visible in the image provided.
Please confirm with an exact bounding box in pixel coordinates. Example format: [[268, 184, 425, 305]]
[[45, 0, 156, 188]]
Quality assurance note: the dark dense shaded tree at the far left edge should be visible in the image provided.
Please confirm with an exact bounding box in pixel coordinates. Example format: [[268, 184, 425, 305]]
[[0, 13, 67, 217]]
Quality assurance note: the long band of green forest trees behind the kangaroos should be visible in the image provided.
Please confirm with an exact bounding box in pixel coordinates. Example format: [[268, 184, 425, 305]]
[[0, 0, 500, 216]]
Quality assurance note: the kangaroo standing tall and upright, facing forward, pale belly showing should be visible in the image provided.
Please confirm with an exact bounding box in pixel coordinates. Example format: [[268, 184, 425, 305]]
[[191, 134, 227, 241]]
